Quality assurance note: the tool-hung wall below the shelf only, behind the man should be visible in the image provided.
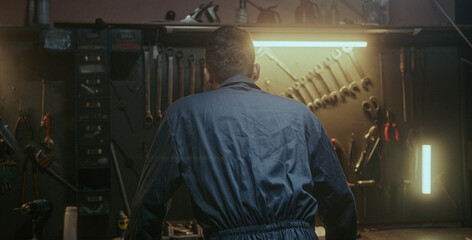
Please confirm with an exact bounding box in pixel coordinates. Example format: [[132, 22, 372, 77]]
[[0, 26, 465, 239]]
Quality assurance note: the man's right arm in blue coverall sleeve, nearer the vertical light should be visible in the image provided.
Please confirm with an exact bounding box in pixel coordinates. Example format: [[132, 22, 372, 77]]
[[308, 114, 357, 240]]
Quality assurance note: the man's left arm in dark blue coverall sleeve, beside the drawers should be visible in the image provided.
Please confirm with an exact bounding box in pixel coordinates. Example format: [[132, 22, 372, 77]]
[[126, 117, 182, 240]]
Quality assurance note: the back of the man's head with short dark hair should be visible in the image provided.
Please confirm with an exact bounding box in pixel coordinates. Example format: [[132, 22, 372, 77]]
[[206, 26, 255, 83]]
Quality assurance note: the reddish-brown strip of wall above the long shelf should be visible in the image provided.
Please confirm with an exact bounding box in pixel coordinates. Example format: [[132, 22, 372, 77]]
[[0, 0, 454, 26]]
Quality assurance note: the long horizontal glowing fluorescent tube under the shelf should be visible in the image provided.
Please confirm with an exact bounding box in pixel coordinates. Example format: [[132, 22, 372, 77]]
[[253, 41, 367, 47]]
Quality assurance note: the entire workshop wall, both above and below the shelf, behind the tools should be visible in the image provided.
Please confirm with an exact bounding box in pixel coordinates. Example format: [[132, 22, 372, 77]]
[[0, 0, 472, 239]]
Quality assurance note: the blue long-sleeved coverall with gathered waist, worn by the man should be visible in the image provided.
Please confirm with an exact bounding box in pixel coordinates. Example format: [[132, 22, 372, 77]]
[[127, 75, 357, 240]]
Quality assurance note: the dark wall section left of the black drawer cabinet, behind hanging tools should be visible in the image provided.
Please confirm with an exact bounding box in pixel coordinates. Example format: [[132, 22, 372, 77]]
[[0, 29, 75, 239]]
